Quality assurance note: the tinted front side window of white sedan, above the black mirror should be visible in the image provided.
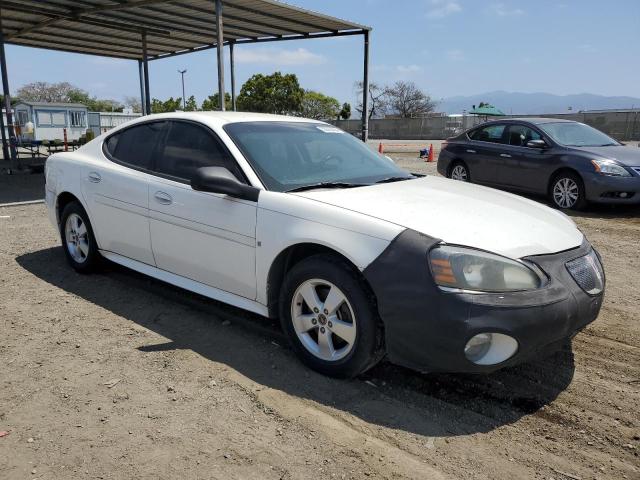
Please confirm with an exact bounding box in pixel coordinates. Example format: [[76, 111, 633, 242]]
[[155, 121, 244, 181]]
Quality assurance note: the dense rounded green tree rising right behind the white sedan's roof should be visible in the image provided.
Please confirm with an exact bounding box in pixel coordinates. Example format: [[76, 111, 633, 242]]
[[238, 72, 304, 115]]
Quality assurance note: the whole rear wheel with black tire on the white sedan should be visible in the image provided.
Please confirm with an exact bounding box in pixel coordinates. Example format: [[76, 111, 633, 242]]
[[60, 202, 100, 273]]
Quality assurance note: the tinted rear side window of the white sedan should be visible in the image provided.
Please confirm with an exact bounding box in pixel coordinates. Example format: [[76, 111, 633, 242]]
[[105, 122, 164, 170]]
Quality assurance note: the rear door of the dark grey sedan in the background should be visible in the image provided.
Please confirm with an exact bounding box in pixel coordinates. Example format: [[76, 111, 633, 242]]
[[464, 123, 507, 183]]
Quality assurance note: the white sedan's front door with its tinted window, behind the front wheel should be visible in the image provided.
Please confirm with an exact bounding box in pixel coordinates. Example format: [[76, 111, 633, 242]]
[[149, 120, 257, 299]]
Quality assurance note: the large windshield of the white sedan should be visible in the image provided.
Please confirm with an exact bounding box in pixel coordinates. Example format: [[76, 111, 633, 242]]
[[224, 122, 413, 192]]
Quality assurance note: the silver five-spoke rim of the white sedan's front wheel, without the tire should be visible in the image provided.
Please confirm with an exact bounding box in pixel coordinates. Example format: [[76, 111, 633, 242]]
[[291, 278, 356, 361]]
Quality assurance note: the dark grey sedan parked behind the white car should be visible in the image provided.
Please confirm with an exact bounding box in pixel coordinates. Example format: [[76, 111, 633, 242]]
[[438, 118, 640, 209]]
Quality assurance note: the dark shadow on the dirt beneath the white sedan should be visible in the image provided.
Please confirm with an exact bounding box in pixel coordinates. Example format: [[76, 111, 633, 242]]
[[16, 247, 574, 437]]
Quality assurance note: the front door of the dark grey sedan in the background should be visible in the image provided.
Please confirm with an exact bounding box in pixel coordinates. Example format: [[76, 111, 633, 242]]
[[497, 124, 550, 192]]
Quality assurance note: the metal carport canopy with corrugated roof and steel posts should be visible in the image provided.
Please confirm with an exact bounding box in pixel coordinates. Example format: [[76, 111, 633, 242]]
[[0, 0, 371, 166]]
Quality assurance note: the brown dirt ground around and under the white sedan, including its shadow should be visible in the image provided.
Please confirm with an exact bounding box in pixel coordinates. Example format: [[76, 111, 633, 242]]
[[0, 160, 640, 480]]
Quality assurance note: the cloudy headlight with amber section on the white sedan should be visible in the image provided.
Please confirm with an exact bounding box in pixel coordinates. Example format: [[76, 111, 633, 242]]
[[429, 245, 546, 292]]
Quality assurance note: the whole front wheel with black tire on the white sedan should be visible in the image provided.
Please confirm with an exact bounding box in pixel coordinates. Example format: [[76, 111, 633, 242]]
[[280, 254, 384, 378]]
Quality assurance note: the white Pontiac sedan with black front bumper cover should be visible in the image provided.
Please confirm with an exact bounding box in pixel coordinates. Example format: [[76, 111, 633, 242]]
[[46, 112, 605, 377]]
